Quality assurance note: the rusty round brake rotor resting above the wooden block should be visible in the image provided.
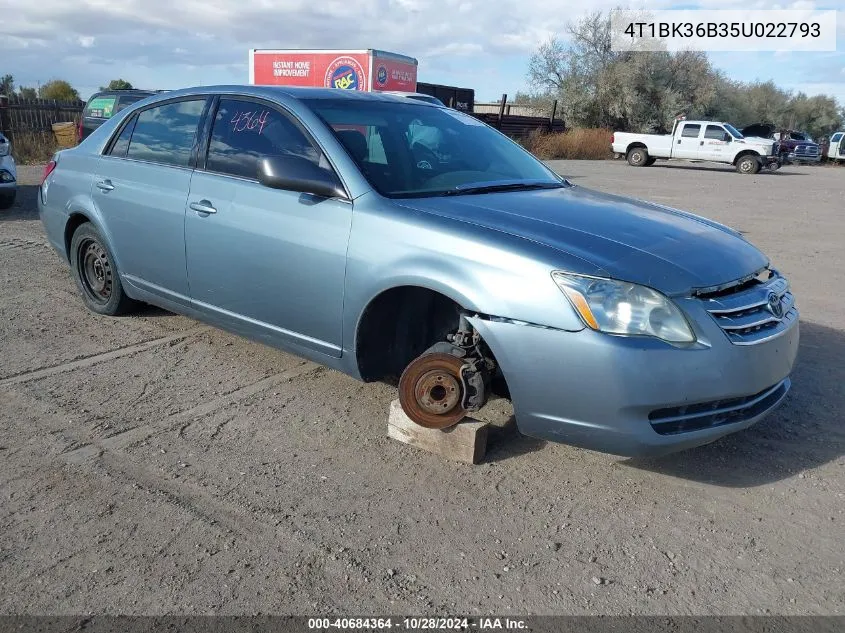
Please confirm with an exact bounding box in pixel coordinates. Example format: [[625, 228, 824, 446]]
[[399, 353, 466, 429]]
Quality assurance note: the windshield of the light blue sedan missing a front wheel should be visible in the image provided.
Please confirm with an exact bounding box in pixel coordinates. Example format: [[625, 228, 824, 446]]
[[306, 99, 568, 198]]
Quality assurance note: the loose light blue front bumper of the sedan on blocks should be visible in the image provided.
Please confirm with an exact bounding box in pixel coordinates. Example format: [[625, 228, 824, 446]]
[[472, 300, 799, 456]]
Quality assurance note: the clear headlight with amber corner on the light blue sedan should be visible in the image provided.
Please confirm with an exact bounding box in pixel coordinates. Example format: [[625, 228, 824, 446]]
[[552, 271, 695, 343]]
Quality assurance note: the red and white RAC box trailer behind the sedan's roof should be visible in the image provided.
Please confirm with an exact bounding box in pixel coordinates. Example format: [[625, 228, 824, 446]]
[[249, 49, 417, 92]]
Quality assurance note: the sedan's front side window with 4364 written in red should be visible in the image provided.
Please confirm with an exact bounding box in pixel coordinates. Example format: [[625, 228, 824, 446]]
[[206, 99, 328, 178]]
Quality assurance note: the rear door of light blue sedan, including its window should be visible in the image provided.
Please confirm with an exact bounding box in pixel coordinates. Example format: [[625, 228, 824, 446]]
[[93, 97, 207, 305]]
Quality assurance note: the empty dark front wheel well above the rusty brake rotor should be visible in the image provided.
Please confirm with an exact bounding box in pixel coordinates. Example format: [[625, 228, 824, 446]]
[[355, 286, 461, 382]]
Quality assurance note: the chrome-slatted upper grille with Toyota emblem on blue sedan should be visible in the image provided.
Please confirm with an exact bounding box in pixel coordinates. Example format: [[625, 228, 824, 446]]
[[698, 270, 798, 345]]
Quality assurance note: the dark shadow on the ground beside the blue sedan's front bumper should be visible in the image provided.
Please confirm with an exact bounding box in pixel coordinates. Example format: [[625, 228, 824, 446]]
[[620, 322, 845, 488]]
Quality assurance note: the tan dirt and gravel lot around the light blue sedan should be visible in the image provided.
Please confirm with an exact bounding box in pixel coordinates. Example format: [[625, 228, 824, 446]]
[[0, 161, 845, 615]]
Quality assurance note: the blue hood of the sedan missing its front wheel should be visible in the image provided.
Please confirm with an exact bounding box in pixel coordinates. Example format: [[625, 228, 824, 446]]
[[400, 186, 768, 296]]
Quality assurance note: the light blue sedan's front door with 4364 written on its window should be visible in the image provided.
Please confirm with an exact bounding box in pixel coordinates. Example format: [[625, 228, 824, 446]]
[[185, 97, 352, 356]]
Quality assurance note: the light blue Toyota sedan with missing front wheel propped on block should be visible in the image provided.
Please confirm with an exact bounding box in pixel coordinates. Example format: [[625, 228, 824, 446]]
[[39, 86, 798, 455]]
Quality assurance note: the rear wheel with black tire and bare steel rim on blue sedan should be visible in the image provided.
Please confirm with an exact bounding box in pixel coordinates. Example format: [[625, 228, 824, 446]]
[[69, 222, 135, 316]]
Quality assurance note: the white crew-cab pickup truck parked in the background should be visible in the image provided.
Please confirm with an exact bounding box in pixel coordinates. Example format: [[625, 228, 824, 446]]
[[611, 120, 781, 174]]
